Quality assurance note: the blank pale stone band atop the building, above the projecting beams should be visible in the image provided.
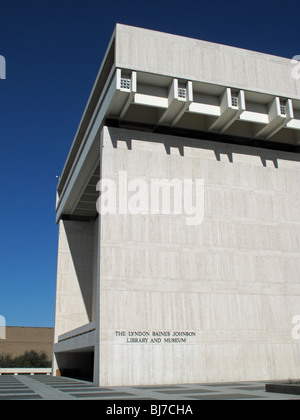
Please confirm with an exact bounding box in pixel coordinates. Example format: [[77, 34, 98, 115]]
[[116, 24, 300, 99]]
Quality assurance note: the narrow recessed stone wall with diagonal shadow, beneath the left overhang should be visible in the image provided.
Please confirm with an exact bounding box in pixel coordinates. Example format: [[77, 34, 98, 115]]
[[55, 220, 95, 342]]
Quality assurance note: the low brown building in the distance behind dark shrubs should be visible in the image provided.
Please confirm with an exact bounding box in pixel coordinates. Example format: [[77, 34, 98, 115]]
[[0, 327, 54, 360]]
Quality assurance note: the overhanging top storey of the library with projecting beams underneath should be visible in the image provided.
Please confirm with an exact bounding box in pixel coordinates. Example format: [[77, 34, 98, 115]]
[[57, 24, 300, 220]]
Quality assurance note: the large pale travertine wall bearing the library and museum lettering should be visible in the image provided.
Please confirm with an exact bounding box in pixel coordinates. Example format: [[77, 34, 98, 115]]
[[96, 127, 300, 385]]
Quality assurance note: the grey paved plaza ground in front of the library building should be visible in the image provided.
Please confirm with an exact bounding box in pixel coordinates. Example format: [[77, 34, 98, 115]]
[[0, 375, 300, 401]]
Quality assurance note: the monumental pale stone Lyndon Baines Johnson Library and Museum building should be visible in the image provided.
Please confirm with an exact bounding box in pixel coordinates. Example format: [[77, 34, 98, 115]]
[[53, 24, 300, 386]]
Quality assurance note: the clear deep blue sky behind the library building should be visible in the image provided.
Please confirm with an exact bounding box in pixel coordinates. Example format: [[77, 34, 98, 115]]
[[0, 0, 300, 327]]
